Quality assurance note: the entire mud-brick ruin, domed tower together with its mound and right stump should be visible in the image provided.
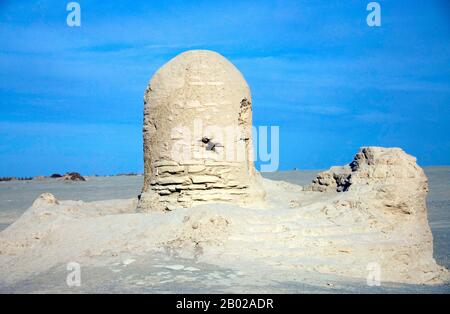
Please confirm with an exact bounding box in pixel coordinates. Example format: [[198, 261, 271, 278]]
[[0, 51, 449, 292]]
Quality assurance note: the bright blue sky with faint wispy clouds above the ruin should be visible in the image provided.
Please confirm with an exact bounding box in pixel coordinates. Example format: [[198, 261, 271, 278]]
[[0, 0, 450, 176]]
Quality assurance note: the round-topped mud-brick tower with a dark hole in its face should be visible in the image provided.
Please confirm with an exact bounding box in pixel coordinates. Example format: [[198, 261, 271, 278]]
[[138, 50, 263, 211]]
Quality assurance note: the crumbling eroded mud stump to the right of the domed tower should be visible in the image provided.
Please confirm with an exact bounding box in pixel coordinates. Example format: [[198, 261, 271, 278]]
[[305, 147, 446, 282]]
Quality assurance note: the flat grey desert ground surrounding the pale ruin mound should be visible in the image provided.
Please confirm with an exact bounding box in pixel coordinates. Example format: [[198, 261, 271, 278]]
[[0, 167, 450, 293]]
